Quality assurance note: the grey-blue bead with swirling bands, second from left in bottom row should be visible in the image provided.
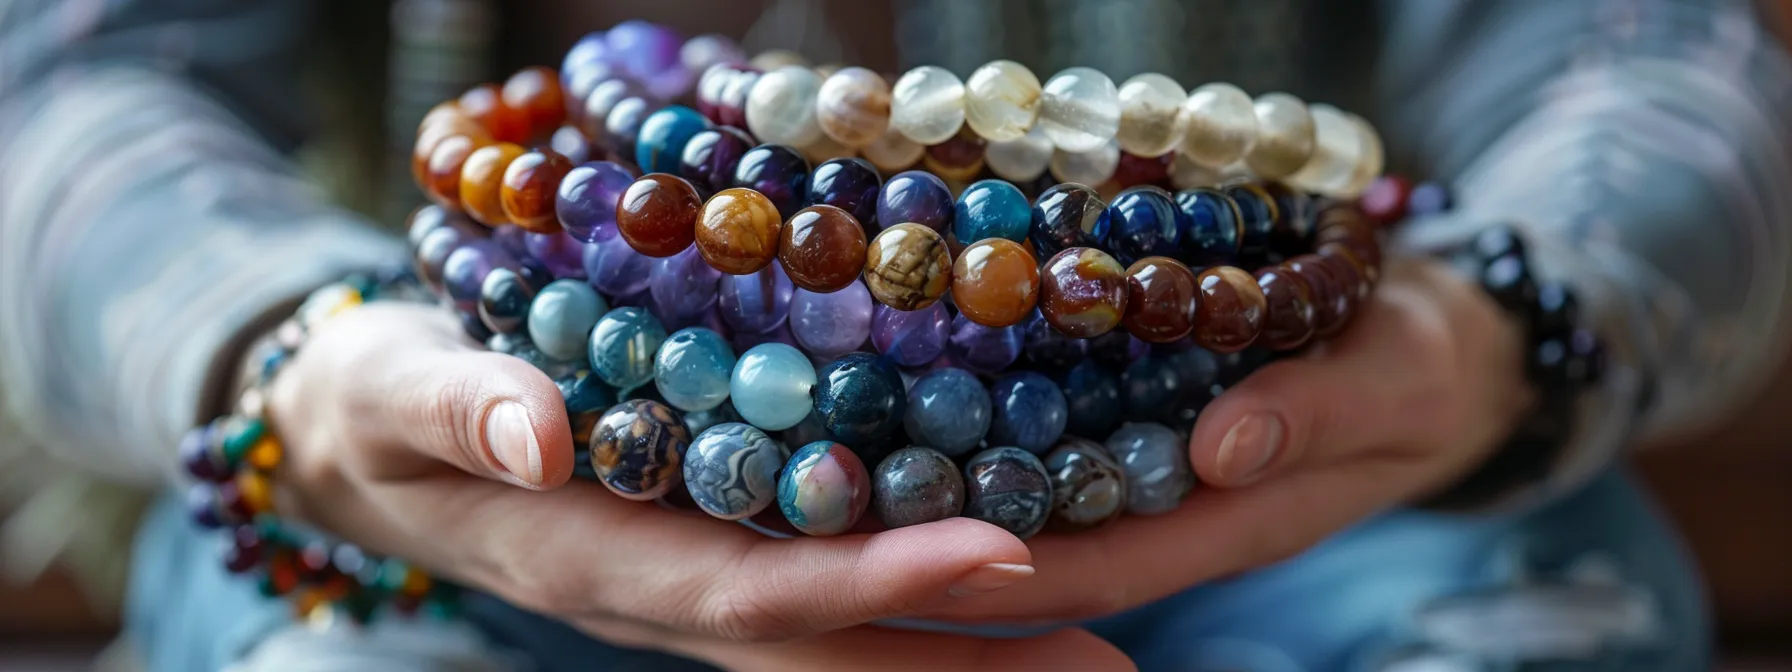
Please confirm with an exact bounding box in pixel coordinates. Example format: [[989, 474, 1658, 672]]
[[685, 423, 788, 520]]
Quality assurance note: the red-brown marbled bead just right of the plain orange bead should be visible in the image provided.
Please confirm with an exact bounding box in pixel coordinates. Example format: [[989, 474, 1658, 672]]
[[1039, 247, 1127, 339]]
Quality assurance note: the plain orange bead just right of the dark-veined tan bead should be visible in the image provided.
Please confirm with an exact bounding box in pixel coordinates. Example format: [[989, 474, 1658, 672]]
[[952, 238, 1039, 326]]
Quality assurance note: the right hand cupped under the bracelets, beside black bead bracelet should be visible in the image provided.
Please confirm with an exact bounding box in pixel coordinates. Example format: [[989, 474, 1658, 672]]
[[932, 260, 1530, 622]]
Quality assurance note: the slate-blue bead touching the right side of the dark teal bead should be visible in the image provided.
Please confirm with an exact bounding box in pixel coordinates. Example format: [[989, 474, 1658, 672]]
[[903, 369, 995, 457]]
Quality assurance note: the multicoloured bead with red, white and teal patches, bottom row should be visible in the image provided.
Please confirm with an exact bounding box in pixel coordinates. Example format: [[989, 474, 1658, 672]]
[[778, 441, 871, 536]]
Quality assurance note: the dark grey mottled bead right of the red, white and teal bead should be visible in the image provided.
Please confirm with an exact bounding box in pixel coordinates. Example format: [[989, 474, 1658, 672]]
[[871, 446, 964, 529]]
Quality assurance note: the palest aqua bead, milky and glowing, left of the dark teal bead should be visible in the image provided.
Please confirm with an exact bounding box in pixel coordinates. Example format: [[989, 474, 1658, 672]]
[[728, 342, 815, 432]]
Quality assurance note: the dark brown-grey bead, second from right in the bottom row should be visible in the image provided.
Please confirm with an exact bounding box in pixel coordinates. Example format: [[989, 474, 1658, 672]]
[[1045, 435, 1127, 532]]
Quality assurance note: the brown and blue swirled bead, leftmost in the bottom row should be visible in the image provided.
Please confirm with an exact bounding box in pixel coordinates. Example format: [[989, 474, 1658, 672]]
[[591, 400, 690, 502]]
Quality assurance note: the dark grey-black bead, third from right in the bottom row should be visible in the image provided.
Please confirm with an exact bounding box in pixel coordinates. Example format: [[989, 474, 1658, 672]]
[[964, 446, 1052, 539]]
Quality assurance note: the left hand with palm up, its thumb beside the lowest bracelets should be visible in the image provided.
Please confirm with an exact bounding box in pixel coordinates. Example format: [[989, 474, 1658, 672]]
[[269, 305, 1131, 670]]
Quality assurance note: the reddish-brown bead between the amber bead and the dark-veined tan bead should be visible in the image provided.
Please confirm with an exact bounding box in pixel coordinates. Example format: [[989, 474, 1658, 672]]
[[778, 206, 866, 294]]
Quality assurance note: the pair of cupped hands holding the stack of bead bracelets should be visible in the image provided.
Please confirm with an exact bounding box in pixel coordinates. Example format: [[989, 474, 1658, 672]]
[[269, 260, 1529, 672]]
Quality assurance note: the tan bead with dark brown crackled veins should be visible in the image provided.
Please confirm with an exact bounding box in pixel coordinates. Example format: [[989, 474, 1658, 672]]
[[866, 222, 952, 310]]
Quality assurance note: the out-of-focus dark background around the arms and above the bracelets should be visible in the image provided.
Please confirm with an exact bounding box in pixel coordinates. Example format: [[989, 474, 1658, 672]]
[[0, 0, 1792, 670]]
